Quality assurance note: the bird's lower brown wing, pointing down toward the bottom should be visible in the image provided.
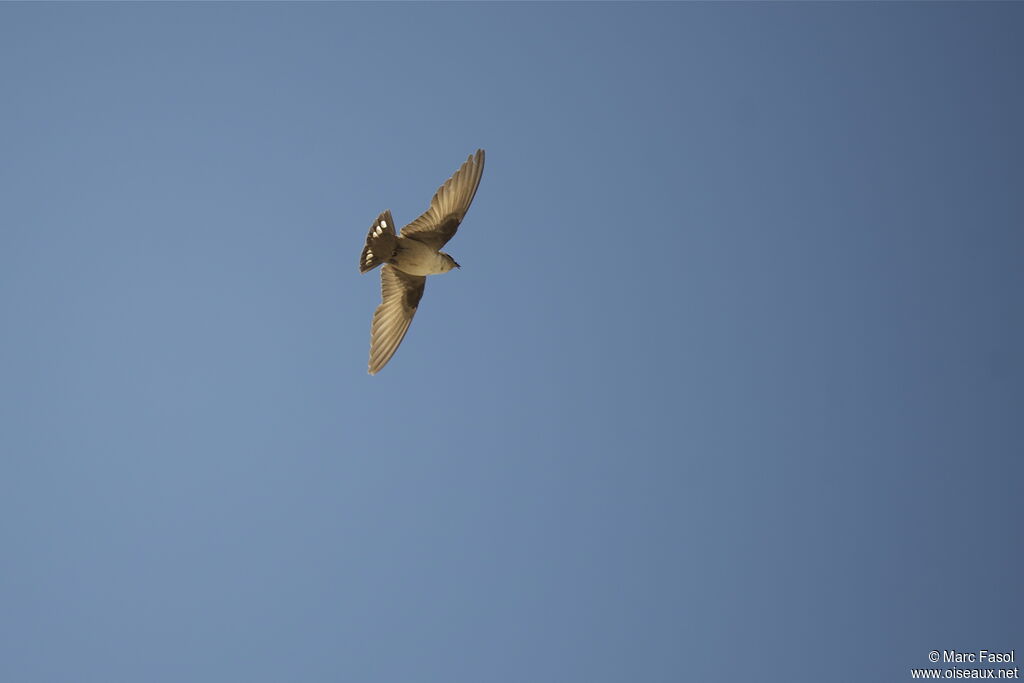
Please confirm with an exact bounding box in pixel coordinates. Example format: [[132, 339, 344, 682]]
[[370, 264, 427, 375]]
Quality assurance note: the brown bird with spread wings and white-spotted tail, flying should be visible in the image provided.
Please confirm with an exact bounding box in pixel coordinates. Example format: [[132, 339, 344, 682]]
[[359, 150, 483, 375]]
